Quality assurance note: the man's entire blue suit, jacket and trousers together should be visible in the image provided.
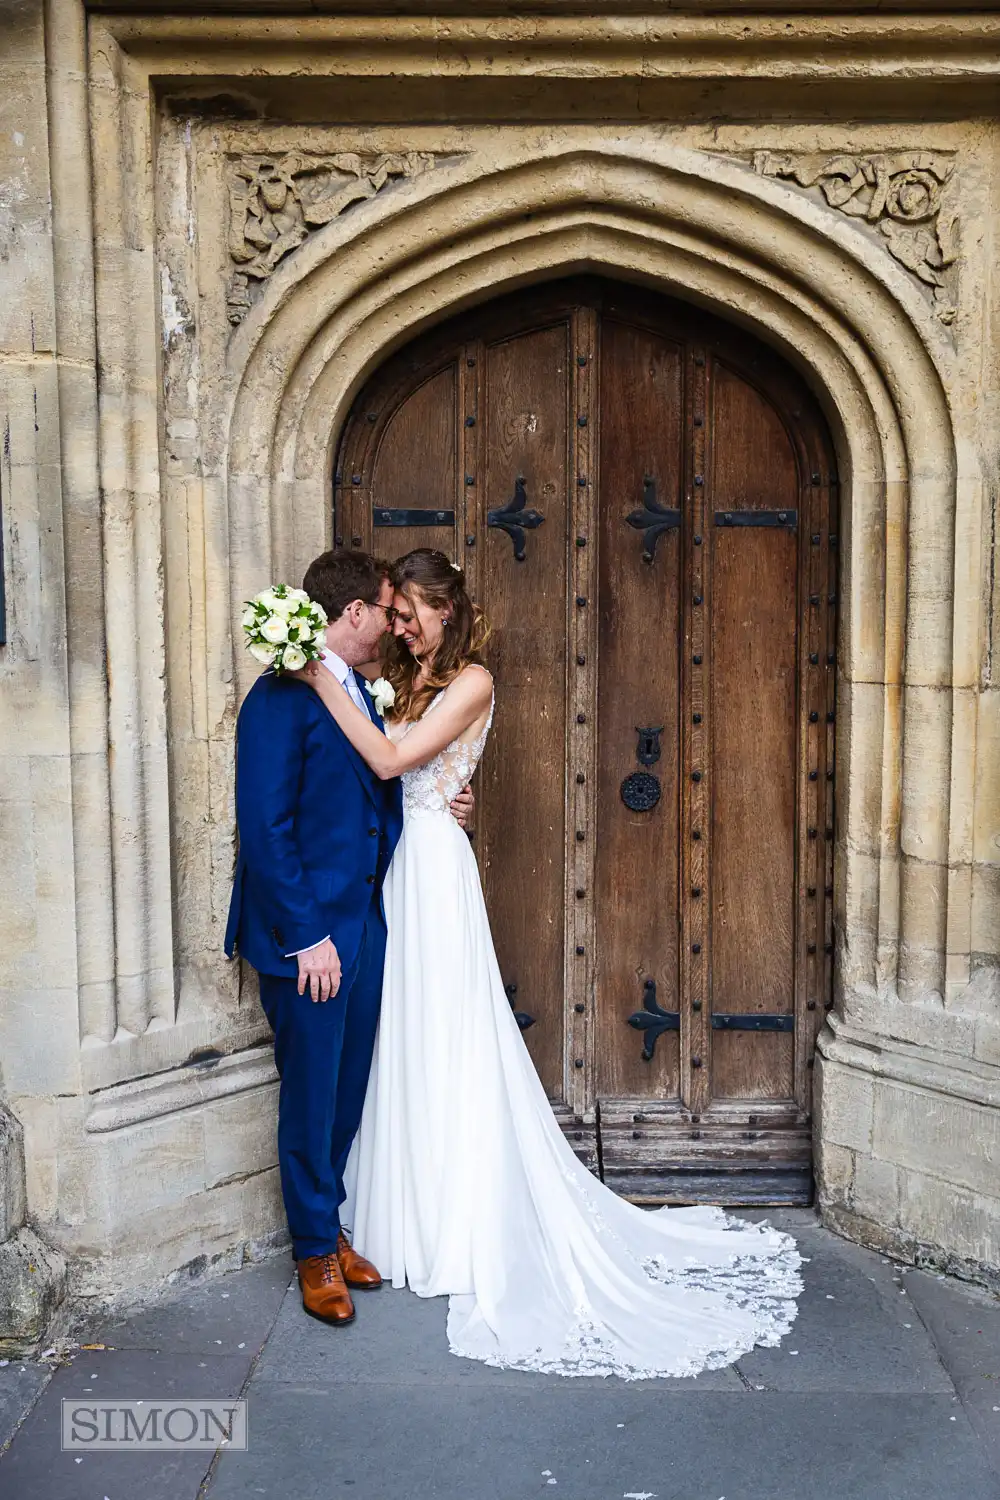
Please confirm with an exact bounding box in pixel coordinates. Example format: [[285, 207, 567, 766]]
[[225, 672, 403, 1259]]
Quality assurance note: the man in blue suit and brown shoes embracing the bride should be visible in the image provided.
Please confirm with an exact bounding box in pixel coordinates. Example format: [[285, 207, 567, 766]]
[[225, 552, 472, 1325]]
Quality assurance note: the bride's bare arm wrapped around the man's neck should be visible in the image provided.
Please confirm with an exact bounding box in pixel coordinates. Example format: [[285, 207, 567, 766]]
[[289, 662, 493, 782]]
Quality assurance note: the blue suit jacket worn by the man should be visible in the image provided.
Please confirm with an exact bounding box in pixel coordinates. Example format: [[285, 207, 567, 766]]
[[225, 672, 403, 977]]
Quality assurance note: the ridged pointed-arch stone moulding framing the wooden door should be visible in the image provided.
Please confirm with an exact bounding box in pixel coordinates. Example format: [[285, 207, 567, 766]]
[[219, 143, 972, 1056]]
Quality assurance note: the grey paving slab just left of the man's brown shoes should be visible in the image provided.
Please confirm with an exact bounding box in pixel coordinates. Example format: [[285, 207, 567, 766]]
[[88, 1254, 295, 1355]]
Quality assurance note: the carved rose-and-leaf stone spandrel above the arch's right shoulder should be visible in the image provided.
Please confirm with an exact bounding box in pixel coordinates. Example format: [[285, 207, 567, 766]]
[[753, 152, 958, 323]]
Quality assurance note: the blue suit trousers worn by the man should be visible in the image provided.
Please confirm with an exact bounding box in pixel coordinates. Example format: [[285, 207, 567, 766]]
[[259, 887, 385, 1260]]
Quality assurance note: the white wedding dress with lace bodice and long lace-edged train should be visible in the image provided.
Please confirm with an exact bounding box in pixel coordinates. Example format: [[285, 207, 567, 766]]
[[345, 675, 802, 1380]]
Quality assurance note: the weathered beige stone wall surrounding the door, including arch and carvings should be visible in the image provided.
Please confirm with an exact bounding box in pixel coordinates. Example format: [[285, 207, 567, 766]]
[[0, 0, 1000, 1326]]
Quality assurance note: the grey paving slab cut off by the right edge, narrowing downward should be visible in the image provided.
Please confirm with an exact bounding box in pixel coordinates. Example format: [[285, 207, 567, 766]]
[[903, 1271, 1000, 1476]]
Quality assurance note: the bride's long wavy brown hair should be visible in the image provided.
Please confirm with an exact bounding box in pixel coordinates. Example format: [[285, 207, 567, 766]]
[[382, 548, 490, 719]]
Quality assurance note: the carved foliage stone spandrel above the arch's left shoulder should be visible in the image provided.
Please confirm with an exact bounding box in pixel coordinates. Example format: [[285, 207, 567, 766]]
[[228, 152, 435, 323]]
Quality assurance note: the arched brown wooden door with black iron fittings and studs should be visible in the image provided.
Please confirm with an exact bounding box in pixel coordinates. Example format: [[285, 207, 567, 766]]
[[336, 281, 837, 1203]]
